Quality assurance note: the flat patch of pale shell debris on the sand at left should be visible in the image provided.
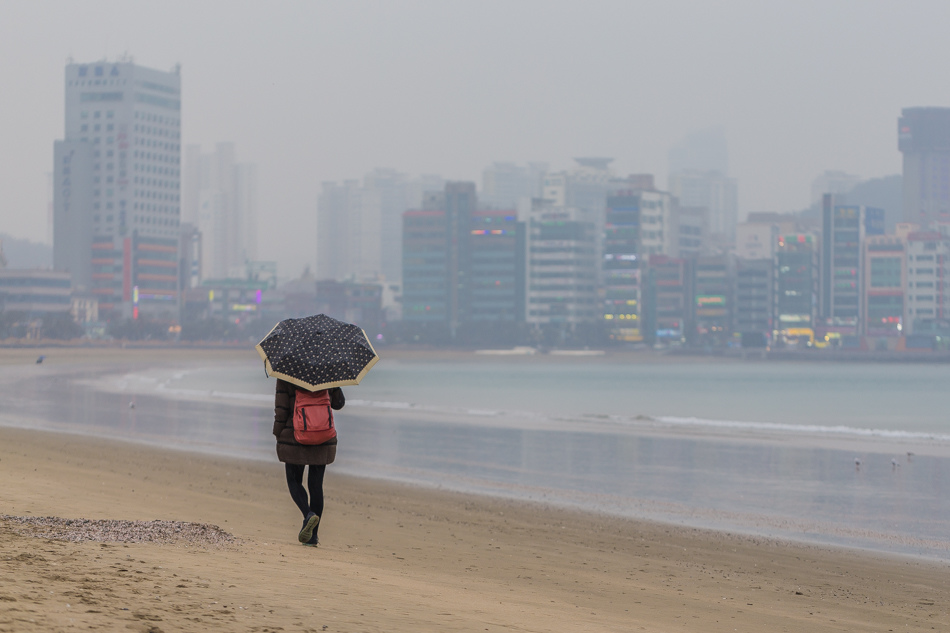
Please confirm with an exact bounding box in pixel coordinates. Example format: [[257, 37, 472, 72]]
[[0, 514, 238, 546]]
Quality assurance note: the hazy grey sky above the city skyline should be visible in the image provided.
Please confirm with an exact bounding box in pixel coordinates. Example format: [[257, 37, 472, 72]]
[[0, 0, 950, 276]]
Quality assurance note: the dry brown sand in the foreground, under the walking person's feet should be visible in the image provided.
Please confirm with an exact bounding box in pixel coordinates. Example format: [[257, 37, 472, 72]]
[[0, 428, 950, 632]]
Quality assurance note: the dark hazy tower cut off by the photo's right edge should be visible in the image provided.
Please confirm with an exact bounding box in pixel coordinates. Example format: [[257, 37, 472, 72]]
[[897, 108, 950, 226]]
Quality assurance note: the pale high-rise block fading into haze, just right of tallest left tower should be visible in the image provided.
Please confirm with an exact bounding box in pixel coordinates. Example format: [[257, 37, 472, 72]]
[[182, 143, 257, 279]]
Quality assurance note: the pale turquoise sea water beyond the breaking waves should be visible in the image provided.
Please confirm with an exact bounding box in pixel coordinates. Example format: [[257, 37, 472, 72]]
[[166, 359, 950, 438]]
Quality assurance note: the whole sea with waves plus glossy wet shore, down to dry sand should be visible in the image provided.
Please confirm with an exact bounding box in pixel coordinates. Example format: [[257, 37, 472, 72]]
[[0, 355, 950, 560]]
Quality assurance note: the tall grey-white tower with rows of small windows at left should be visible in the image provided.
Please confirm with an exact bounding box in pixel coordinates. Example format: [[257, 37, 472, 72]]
[[53, 60, 181, 321]]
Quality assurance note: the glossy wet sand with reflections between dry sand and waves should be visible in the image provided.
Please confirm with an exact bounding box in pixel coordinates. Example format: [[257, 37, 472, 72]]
[[0, 360, 950, 558]]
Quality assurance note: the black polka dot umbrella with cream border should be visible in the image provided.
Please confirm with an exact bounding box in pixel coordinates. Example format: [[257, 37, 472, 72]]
[[255, 314, 379, 391]]
